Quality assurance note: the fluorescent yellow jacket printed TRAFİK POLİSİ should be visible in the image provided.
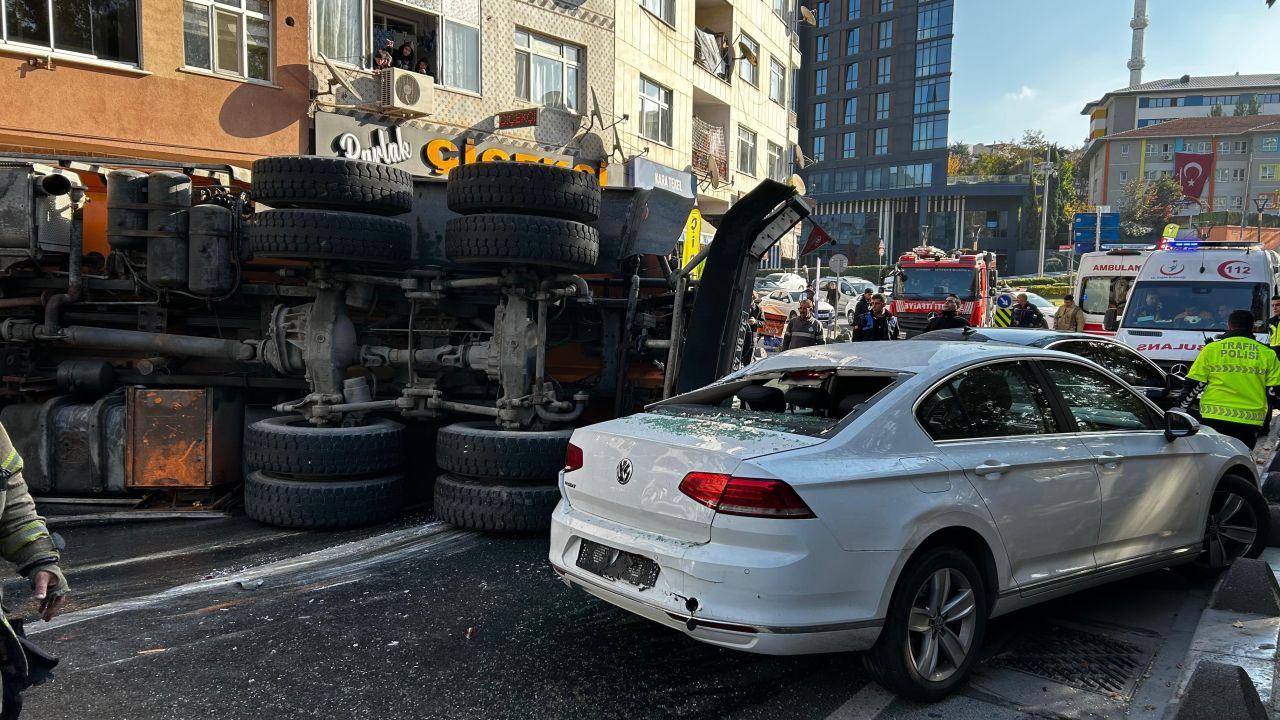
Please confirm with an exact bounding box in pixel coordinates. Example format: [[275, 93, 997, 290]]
[[1187, 337, 1280, 425]]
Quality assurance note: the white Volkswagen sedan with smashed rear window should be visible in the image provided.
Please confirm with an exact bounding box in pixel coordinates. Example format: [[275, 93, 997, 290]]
[[550, 340, 1268, 701]]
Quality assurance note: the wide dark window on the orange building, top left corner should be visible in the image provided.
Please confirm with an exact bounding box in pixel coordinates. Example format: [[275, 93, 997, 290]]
[[0, 0, 138, 65]]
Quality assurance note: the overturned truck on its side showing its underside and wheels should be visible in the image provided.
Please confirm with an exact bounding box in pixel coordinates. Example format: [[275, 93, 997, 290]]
[[0, 156, 808, 530]]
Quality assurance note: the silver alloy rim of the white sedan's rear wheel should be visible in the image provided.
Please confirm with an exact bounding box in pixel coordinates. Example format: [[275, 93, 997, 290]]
[[906, 568, 977, 683]]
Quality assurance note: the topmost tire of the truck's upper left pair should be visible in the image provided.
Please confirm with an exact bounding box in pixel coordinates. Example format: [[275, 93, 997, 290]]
[[252, 155, 413, 215]]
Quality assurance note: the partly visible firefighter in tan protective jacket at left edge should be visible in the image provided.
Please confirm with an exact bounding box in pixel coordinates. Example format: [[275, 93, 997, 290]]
[[0, 427, 68, 720]]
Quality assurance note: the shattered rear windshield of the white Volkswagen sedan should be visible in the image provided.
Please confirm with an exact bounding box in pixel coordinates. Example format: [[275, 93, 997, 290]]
[[648, 370, 899, 437]]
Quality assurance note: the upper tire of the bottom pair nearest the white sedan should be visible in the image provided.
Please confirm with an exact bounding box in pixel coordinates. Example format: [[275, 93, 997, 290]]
[[435, 420, 573, 482]]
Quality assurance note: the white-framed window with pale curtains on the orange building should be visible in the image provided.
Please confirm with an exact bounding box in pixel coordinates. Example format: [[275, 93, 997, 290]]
[[182, 0, 273, 82]]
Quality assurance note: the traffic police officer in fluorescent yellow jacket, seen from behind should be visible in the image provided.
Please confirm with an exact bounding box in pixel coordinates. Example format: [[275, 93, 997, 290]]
[[1180, 310, 1280, 452]]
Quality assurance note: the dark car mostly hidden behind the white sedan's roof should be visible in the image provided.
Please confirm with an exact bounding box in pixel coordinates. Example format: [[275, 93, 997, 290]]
[[911, 328, 1183, 410]]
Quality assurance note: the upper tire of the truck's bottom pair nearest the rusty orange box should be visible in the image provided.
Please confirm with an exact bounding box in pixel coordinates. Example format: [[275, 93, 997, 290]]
[[244, 415, 404, 478]]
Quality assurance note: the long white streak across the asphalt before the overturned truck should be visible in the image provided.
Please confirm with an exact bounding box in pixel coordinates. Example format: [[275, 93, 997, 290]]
[[27, 521, 480, 635]]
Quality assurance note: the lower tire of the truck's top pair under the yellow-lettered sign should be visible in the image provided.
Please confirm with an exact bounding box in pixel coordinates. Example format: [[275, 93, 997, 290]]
[[444, 214, 600, 270]]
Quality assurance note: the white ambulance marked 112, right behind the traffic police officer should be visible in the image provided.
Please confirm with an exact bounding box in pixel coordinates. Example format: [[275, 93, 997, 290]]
[[1116, 241, 1280, 374]]
